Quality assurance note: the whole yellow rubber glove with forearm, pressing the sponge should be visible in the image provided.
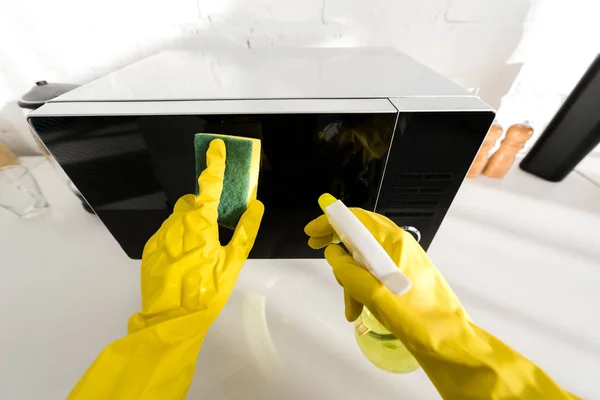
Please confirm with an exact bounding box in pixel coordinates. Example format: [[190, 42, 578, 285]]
[[69, 139, 264, 400]]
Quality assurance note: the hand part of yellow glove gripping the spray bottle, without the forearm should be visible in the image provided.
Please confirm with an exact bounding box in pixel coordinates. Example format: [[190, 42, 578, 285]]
[[305, 208, 468, 334]]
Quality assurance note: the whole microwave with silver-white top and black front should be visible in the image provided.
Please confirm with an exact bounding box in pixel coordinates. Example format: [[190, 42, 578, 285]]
[[29, 48, 494, 258]]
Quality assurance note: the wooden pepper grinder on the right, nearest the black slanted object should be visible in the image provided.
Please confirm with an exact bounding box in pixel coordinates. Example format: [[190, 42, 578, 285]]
[[483, 122, 533, 179]]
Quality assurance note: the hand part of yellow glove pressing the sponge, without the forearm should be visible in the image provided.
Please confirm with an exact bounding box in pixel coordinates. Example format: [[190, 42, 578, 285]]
[[129, 139, 264, 333]]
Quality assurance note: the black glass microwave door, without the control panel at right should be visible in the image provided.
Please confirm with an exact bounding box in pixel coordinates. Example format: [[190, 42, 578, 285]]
[[33, 113, 396, 258]]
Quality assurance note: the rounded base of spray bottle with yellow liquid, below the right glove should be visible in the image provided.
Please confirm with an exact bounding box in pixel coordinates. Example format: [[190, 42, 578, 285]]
[[354, 307, 419, 374]]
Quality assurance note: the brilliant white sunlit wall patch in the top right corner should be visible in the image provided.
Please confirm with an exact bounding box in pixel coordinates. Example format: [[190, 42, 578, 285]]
[[498, 0, 600, 147]]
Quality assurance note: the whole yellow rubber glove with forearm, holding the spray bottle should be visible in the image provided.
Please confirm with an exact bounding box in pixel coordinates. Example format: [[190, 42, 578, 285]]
[[305, 208, 576, 399]]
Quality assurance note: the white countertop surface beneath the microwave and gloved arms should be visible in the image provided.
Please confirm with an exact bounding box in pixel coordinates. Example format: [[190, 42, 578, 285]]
[[0, 158, 600, 400]]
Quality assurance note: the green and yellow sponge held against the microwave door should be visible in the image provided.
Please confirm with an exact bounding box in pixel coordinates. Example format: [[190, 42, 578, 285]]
[[194, 133, 260, 229]]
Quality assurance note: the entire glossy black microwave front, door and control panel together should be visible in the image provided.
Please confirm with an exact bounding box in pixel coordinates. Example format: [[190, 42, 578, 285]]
[[31, 112, 493, 258]]
